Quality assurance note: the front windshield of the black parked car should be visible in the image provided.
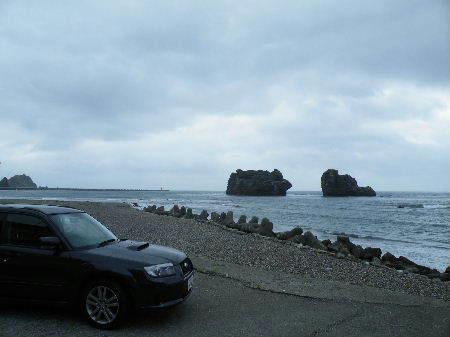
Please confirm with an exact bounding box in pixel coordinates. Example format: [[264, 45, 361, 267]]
[[52, 213, 117, 248]]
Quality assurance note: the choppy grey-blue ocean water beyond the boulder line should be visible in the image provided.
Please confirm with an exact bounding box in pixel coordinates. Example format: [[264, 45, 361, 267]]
[[0, 190, 450, 271]]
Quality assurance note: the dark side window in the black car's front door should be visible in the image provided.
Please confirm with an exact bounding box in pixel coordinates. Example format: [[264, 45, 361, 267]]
[[3, 214, 55, 247]]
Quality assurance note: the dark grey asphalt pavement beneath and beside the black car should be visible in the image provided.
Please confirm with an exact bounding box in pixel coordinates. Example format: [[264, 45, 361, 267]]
[[0, 273, 450, 336]]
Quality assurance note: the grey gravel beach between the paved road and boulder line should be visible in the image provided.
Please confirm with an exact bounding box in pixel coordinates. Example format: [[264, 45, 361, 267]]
[[1, 199, 450, 301]]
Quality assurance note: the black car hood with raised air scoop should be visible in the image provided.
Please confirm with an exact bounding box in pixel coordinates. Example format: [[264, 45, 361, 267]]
[[91, 240, 186, 266]]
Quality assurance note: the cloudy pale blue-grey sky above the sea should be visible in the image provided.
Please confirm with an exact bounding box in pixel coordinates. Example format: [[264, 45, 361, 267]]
[[0, 0, 450, 191]]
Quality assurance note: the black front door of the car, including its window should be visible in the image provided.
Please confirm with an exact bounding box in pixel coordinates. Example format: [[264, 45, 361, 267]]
[[0, 213, 73, 301]]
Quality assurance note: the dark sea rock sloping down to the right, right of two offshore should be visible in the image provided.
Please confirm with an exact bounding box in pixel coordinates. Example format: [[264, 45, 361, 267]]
[[320, 169, 376, 197]]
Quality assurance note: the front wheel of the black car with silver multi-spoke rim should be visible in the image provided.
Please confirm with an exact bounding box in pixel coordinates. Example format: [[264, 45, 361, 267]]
[[81, 280, 129, 329]]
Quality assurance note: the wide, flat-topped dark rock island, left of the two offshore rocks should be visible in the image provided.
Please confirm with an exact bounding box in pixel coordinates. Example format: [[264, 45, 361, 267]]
[[226, 169, 292, 196]]
